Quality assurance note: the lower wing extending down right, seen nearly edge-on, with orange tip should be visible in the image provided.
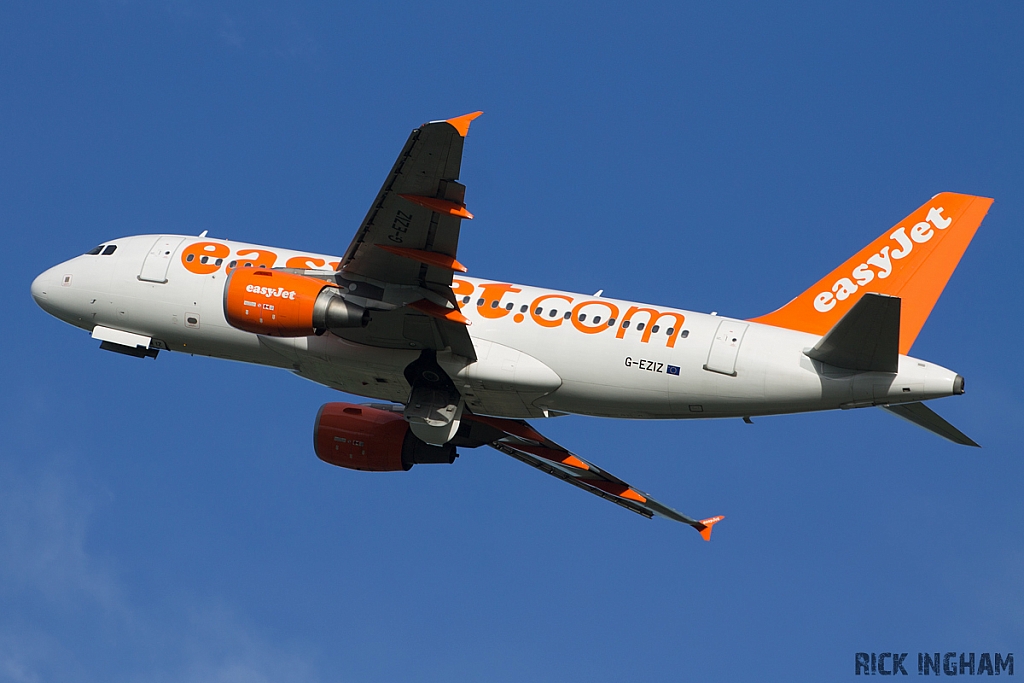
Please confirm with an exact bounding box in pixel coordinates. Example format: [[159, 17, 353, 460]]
[[455, 414, 725, 541]]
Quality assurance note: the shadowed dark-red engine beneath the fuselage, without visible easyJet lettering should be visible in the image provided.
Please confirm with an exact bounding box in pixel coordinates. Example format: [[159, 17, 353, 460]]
[[313, 403, 459, 472]]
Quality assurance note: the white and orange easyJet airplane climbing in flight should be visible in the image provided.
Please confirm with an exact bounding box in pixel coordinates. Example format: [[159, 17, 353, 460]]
[[32, 112, 992, 541]]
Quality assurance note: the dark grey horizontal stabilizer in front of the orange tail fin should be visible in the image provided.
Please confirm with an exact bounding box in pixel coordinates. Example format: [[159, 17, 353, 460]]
[[807, 293, 900, 373]]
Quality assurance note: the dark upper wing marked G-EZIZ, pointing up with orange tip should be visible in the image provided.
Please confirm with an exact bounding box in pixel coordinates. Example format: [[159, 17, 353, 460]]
[[337, 112, 480, 359]]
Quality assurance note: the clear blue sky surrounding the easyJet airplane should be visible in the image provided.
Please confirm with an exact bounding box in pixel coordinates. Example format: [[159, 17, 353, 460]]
[[0, 1, 1024, 682]]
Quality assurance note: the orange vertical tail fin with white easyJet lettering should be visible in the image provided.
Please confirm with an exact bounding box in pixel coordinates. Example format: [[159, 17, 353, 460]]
[[752, 193, 992, 353]]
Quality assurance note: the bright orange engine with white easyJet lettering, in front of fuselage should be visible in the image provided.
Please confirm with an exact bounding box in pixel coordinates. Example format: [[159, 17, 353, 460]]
[[224, 268, 370, 337]]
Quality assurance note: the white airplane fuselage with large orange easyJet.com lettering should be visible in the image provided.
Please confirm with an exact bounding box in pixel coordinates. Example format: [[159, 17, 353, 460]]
[[32, 234, 956, 419]]
